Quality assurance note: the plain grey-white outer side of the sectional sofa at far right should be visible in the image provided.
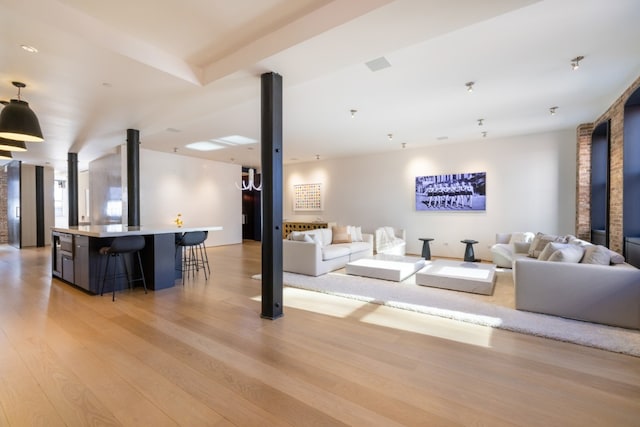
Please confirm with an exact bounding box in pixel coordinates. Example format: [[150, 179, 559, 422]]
[[513, 258, 640, 329]]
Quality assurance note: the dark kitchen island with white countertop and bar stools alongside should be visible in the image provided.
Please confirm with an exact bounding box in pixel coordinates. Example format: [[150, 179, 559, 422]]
[[51, 224, 222, 294]]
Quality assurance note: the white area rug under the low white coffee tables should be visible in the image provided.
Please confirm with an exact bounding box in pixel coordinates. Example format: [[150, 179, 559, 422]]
[[253, 270, 640, 357]]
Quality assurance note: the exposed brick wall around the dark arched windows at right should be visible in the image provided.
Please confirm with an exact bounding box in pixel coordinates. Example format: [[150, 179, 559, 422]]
[[576, 77, 640, 253]]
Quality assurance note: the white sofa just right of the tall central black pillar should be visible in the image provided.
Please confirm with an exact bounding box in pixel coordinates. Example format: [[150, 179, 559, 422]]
[[282, 226, 373, 276]]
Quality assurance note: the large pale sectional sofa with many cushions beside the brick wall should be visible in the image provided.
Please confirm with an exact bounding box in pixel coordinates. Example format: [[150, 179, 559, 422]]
[[492, 233, 640, 329]]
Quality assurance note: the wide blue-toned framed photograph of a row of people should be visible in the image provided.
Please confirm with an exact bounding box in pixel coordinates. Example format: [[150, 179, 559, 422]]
[[415, 172, 487, 211]]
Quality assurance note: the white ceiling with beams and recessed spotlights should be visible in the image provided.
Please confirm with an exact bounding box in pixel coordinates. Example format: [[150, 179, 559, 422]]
[[0, 0, 640, 174]]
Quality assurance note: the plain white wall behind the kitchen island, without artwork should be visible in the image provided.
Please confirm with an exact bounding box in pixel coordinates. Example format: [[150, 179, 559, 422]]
[[140, 149, 242, 246]]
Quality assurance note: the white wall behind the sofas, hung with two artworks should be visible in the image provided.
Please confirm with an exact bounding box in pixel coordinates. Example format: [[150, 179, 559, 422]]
[[283, 131, 576, 259]]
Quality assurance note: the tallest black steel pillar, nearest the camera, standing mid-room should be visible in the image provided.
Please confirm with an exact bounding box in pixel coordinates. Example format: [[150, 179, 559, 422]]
[[260, 73, 283, 319]]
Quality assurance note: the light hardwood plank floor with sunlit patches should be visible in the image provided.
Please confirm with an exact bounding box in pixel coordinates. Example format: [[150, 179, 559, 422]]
[[0, 242, 640, 427]]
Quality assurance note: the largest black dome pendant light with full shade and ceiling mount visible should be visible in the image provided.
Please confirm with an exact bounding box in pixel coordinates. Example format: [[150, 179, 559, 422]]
[[0, 82, 44, 142]]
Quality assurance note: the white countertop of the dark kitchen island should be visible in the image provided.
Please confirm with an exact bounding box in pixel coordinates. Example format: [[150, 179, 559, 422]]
[[51, 224, 222, 237]]
